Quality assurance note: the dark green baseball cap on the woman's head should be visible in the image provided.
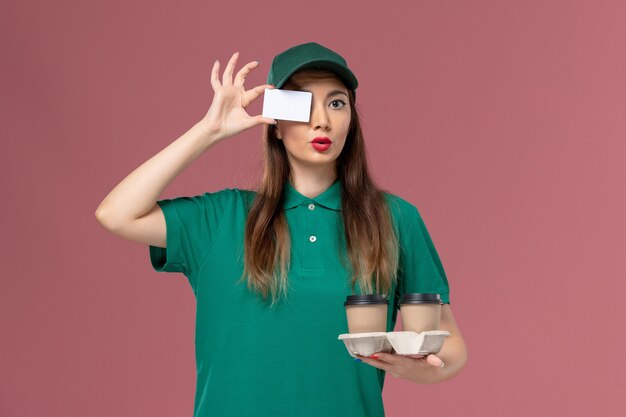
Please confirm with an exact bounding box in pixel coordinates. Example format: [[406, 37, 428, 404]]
[[267, 42, 359, 97]]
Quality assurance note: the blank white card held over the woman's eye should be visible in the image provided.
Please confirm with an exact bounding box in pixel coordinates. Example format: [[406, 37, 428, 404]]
[[262, 88, 313, 122]]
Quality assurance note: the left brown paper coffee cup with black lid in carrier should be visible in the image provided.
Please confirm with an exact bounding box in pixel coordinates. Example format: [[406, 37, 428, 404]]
[[343, 294, 389, 333]]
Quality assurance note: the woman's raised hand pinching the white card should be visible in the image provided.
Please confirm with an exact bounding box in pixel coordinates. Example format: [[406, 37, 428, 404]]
[[201, 52, 275, 141]]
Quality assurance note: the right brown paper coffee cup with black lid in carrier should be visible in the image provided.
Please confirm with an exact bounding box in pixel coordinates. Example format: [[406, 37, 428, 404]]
[[400, 293, 443, 333]]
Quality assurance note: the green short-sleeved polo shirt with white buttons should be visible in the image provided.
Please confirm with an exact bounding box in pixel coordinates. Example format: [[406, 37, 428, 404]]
[[149, 181, 450, 417]]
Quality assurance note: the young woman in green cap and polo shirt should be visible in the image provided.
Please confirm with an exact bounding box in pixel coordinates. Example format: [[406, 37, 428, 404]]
[[96, 42, 467, 417]]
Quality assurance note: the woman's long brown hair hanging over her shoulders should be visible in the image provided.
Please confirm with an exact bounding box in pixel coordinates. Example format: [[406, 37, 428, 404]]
[[242, 70, 399, 305]]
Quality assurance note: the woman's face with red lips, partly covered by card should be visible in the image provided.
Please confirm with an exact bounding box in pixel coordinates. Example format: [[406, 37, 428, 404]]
[[276, 71, 350, 175]]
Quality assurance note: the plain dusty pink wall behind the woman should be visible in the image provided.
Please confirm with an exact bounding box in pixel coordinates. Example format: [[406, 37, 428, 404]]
[[0, 0, 626, 417]]
